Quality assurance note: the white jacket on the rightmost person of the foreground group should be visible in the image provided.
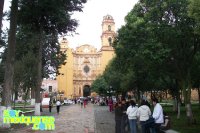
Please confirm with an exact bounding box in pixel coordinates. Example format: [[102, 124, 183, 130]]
[[153, 103, 164, 123]]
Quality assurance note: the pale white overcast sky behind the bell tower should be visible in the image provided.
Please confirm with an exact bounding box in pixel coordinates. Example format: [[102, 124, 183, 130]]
[[4, 0, 138, 49]]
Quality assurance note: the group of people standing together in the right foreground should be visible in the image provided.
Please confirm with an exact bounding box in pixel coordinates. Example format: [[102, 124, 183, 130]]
[[115, 97, 164, 133]]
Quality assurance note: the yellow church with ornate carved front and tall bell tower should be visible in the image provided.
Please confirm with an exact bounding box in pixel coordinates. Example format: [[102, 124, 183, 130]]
[[57, 15, 115, 98]]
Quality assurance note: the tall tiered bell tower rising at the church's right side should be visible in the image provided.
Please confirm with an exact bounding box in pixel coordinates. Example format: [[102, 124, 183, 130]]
[[101, 15, 115, 49]]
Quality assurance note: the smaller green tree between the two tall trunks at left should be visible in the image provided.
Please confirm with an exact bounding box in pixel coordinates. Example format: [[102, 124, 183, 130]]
[[13, 51, 37, 108]]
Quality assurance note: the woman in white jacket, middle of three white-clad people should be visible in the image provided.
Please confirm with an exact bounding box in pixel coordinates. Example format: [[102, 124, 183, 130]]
[[137, 100, 151, 133]]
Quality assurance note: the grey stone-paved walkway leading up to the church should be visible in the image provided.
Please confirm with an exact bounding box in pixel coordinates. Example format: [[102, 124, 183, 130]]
[[0, 104, 115, 133]]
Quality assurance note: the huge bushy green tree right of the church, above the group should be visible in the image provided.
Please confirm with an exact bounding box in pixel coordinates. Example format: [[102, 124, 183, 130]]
[[111, 0, 199, 122]]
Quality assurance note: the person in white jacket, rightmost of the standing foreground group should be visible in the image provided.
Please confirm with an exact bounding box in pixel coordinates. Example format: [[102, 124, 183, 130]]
[[152, 98, 164, 133]]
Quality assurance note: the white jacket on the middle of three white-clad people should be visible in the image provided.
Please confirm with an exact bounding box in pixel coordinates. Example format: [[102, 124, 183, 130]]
[[137, 105, 151, 121]]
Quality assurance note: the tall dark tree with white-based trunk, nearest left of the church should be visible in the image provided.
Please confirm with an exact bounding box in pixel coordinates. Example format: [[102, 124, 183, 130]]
[[16, 0, 86, 115]]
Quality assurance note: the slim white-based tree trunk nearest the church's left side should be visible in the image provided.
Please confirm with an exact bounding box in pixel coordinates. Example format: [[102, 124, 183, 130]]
[[35, 31, 43, 115]]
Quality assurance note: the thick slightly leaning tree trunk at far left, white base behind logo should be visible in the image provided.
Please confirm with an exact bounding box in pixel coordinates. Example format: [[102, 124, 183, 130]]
[[0, 0, 18, 128]]
